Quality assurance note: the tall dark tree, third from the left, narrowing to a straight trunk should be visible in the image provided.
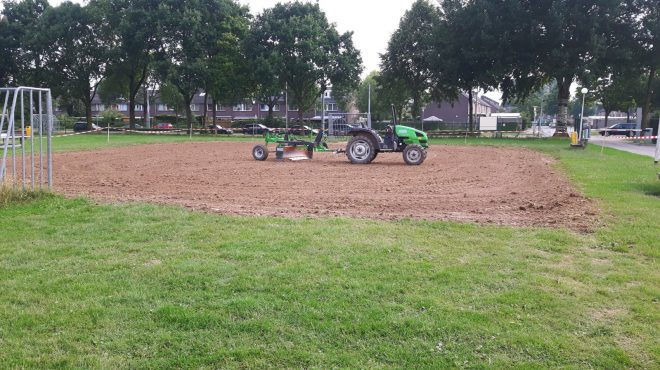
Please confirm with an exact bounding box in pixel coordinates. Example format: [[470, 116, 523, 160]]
[[89, 0, 161, 128]]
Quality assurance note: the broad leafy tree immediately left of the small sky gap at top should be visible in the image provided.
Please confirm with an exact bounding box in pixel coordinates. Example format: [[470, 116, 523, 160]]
[[158, 0, 248, 130]]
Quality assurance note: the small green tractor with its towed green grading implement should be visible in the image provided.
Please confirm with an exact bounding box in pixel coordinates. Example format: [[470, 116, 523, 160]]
[[252, 106, 429, 165]]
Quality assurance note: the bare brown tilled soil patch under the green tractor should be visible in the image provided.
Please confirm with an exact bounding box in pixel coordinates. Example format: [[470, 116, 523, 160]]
[[54, 142, 595, 230]]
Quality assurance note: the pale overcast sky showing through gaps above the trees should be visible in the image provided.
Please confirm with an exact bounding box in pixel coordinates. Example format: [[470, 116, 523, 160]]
[[45, 0, 500, 99]]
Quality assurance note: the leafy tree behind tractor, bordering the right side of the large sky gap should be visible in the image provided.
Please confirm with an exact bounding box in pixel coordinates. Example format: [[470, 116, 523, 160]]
[[380, 0, 441, 118]]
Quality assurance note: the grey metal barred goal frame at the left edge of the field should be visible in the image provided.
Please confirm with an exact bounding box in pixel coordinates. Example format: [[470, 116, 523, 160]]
[[0, 87, 53, 190]]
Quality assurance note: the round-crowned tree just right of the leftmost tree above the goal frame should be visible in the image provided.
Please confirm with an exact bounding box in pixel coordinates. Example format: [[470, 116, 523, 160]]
[[37, 2, 109, 129]]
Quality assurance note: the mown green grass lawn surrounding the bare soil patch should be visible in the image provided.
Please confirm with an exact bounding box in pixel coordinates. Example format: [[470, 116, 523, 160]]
[[0, 135, 660, 368]]
